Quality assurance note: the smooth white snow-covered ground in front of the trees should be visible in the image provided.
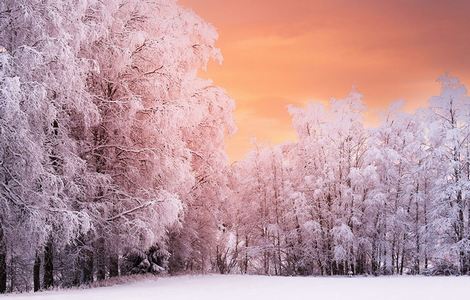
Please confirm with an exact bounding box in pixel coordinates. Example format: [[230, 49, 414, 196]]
[[6, 275, 470, 300]]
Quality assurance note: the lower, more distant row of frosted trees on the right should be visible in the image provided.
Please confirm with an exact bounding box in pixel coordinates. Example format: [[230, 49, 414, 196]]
[[219, 79, 470, 275]]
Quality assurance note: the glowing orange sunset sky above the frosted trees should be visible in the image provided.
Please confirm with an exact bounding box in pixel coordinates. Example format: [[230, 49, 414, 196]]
[[180, 0, 470, 160]]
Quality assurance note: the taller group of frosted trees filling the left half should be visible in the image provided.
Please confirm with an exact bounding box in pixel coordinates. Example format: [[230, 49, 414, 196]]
[[0, 0, 233, 293]]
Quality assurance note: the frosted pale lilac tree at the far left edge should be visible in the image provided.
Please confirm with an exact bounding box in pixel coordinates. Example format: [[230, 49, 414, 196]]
[[0, 1, 102, 290]]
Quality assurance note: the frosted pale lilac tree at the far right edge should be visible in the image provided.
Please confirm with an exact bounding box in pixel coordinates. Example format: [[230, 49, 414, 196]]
[[427, 75, 470, 274]]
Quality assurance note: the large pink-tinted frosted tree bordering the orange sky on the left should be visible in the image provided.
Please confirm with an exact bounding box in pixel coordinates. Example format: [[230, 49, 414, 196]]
[[80, 1, 233, 280]]
